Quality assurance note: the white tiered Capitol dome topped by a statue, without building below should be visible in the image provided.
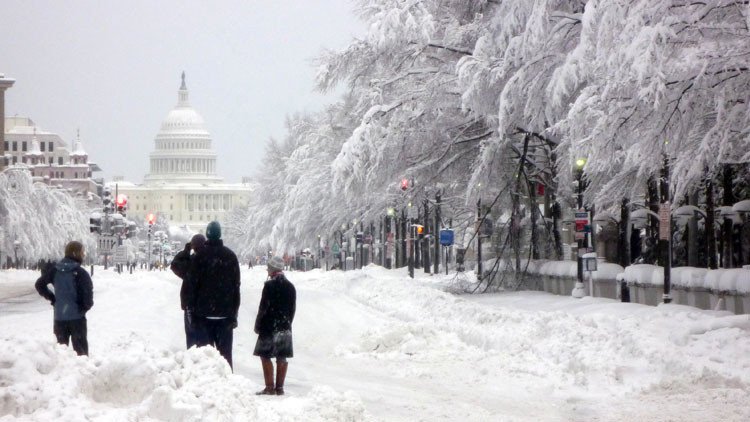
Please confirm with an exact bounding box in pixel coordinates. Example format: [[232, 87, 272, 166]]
[[144, 72, 223, 185]]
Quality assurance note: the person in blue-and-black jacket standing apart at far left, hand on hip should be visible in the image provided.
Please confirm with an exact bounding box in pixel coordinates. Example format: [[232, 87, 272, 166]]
[[34, 241, 94, 356]]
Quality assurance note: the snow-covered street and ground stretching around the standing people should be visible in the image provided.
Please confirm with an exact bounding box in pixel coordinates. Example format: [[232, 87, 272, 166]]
[[0, 267, 750, 421]]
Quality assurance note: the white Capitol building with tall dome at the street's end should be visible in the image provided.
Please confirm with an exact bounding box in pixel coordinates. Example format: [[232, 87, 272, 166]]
[[108, 72, 251, 233]]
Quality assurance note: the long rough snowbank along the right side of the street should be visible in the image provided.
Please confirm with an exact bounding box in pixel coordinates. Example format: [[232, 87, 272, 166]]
[[321, 273, 750, 395]]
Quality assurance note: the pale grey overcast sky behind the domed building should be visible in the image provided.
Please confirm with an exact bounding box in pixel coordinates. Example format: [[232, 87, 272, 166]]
[[0, 0, 364, 182]]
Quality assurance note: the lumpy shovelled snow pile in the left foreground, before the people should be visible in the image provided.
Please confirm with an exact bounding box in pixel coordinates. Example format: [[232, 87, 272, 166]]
[[0, 336, 367, 421]]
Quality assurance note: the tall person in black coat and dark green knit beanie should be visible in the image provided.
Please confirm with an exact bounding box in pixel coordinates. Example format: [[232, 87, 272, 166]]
[[186, 221, 240, 368]]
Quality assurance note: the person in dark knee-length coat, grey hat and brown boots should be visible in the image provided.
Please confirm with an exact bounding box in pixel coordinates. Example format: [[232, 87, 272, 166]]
[[253, 256, 297, 396]]
